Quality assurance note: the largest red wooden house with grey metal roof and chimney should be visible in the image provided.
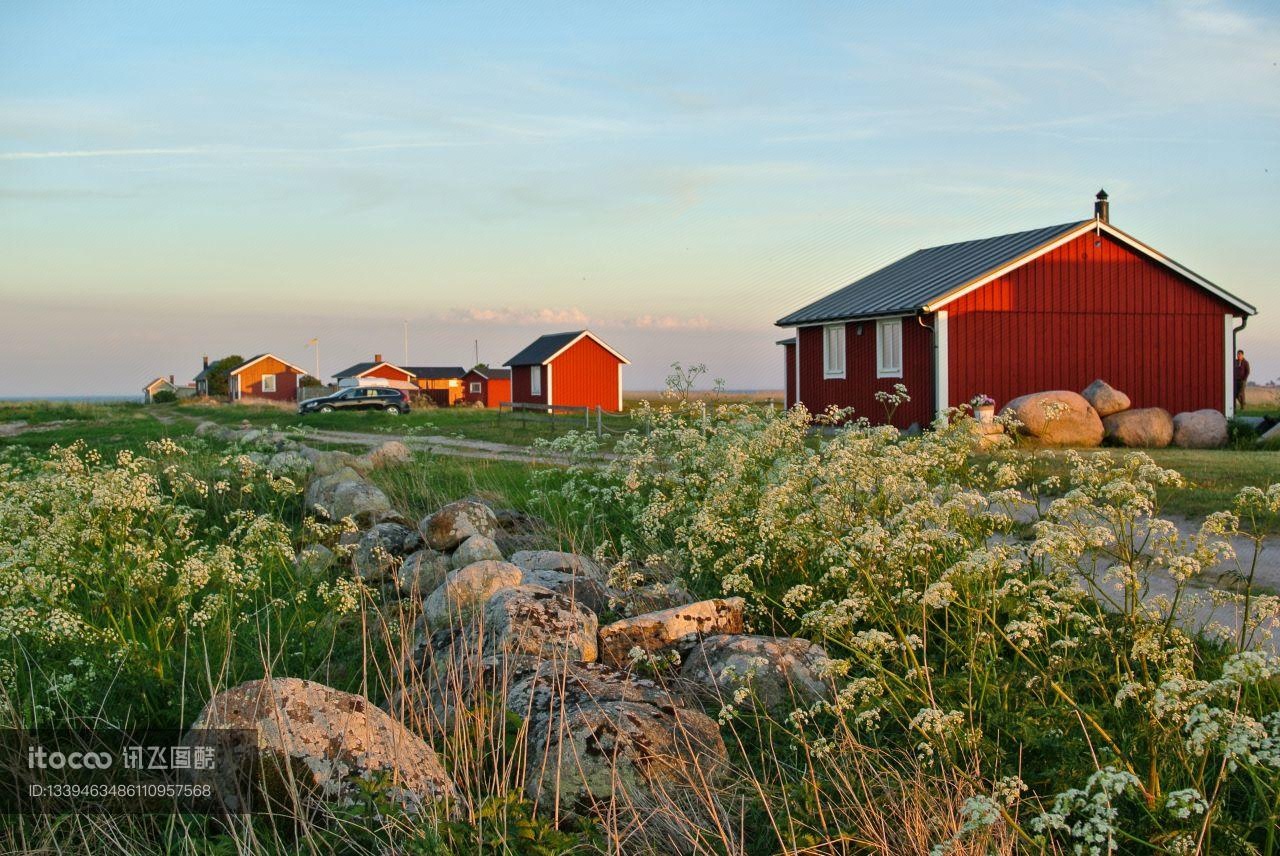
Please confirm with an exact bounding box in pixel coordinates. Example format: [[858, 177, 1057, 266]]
[[777, 191, 1256, 426]]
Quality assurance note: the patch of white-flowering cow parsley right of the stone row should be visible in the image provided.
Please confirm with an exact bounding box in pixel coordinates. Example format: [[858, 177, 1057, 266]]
[[544, 404, 1280, 855]]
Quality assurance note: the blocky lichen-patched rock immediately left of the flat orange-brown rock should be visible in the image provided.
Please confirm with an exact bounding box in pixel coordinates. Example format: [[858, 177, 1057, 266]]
[[480, 585, 599, 663]]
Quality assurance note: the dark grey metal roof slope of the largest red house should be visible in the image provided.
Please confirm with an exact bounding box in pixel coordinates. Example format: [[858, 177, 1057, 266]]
[[777, 220, 1092, 328]]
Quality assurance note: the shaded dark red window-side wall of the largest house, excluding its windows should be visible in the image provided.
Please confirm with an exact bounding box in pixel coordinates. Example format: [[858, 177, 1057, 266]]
[[796, 316, 934, 427]]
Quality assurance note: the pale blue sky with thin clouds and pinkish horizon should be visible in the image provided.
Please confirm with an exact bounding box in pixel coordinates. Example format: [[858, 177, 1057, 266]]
[[0, 0, 1280, 395]]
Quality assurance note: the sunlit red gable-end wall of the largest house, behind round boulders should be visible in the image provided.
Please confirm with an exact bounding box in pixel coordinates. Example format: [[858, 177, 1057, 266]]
[[947, 233, 1231, 413]]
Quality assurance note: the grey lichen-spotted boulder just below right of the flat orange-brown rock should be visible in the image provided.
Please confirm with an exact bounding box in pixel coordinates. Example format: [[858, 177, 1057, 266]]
[[680, 636, 832, 710]]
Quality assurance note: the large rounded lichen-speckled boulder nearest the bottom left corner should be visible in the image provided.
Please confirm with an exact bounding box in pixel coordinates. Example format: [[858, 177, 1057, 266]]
[[192, 678, 458, 811]]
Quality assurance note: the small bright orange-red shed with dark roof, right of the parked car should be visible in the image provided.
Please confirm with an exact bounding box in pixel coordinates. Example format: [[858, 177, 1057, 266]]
[[507, 330, 630, 411]]
